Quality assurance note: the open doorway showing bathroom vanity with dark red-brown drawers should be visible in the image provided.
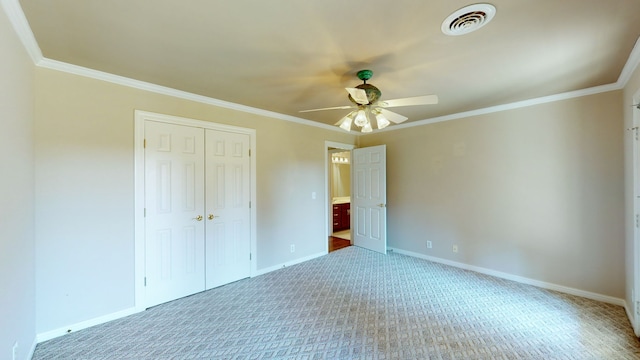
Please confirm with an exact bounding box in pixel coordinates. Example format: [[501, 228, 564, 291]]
[[326, 142, 354, 252]]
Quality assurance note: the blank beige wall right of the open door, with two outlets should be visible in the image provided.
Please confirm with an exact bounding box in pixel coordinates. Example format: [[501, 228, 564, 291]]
[[360, 91, 625, 298]]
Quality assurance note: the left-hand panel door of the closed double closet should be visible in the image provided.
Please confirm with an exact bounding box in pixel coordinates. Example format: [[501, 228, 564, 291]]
[[144, 121, 205, 307]]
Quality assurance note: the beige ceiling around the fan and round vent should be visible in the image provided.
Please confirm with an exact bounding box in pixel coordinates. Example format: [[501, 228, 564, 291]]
[[20, 0, 640, 129]]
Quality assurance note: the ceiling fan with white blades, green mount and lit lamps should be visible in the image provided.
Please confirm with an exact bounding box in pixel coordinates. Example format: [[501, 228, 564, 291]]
[[300, 70, 438, 133]]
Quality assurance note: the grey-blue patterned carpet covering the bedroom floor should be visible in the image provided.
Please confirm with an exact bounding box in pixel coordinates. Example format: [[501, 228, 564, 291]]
[[33, 246, 640, 360]]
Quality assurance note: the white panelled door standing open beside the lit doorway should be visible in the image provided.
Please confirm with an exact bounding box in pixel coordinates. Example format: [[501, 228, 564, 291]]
[[351, 145, 387, 254]]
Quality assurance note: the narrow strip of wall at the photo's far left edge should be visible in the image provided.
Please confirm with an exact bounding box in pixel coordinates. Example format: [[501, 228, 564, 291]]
[[0, 2, 36, 359]]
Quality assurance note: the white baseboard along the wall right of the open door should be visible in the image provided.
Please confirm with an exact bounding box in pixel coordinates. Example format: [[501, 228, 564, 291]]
[[389, 248, 626, 308]]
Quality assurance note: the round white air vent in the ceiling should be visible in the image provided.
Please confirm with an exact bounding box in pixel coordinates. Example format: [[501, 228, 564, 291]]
[[442, 4, 496, 36]]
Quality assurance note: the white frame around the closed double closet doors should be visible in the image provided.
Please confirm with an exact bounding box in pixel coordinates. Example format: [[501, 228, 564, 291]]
[[133, 110, 257, 311]]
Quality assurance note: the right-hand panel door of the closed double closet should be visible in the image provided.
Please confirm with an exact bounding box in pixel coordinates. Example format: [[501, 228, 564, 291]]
[[205, 129, 251, 289]]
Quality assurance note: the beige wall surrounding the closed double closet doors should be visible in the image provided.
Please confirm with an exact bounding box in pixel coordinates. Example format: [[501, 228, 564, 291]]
[[35, 68, 355, 332]]
